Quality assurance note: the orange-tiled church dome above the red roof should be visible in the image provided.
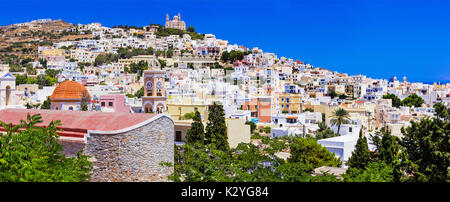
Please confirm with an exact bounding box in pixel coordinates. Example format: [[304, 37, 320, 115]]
[[50, 80, 91, 99]]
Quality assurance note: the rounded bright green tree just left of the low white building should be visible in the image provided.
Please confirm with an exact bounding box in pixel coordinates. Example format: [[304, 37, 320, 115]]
[[288, 137, 342, 169]]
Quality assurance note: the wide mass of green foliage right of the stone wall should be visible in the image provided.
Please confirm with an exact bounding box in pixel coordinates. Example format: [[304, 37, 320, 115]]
[[165, 137, 337, 182]]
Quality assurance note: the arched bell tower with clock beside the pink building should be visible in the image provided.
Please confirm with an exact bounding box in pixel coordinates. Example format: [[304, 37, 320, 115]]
[[142, 61, 167, 113]]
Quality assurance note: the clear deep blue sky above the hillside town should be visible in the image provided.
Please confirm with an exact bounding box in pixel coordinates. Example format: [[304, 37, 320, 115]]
[[0, 0, 450, 82]]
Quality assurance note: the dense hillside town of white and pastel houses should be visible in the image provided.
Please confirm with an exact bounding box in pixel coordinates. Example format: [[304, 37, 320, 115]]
[[0, 15, 450, 169]]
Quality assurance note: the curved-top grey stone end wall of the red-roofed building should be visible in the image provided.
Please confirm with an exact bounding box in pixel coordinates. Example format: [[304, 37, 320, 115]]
[[84, 117, 174, 182]]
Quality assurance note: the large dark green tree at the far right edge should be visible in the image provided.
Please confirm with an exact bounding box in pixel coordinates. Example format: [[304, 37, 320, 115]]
[[400, 118, 450, 182]]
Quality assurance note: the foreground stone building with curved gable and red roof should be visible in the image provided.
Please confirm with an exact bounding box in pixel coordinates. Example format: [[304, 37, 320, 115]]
[[0, 109, 174, 182]]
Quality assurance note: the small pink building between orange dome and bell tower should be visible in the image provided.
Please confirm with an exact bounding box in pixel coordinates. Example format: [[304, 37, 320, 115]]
[[98, 95, 131, 113]]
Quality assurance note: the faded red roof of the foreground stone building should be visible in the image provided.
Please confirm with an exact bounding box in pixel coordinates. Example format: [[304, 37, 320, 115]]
[[0, 109, 156, 137]]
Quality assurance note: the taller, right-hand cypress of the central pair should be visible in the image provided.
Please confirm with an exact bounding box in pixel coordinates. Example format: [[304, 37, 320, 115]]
[[205, 103, 230, 151]]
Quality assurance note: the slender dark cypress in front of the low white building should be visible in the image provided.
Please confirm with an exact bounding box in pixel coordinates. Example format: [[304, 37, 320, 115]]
[[346, 129, 370, 169]]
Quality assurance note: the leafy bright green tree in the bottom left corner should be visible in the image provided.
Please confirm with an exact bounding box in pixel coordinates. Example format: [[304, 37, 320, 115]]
[[0, 114, 92, 182]]
